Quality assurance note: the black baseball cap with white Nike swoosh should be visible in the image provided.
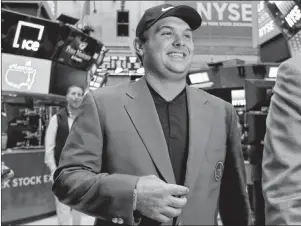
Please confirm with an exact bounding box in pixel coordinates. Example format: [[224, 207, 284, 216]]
[[136, 4, 202, 37]]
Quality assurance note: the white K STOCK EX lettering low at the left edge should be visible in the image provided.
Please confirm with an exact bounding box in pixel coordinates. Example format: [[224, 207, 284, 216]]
[[2, 174, 51, 189]]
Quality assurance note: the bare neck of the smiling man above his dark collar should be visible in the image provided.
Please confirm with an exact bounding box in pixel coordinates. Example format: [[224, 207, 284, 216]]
[[145, 73, 186, 101]]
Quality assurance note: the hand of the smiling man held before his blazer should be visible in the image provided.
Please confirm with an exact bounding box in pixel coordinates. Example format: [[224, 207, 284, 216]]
[[136, 175, 189, 223]]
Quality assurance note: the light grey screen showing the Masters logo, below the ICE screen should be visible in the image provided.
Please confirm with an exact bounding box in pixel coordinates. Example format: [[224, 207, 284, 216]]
[[1, 53, 51, 94]]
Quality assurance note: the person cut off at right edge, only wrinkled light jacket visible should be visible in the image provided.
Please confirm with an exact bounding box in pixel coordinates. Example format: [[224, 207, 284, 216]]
[[262, 53, 301, 225]]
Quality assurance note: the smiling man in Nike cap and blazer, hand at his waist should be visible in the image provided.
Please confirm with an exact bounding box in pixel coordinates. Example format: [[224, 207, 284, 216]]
[[53, 4, 250, 226]]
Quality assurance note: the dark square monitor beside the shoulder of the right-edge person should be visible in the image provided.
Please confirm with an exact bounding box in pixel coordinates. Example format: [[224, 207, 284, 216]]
[[245, 79, 275, 111]]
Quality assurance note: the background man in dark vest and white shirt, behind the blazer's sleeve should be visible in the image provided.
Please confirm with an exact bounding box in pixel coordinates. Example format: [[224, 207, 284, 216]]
[[45, 85, 84, 225]]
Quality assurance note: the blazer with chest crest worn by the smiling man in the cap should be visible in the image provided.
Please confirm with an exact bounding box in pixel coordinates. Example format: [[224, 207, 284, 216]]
[[53, 79, 249, 226]]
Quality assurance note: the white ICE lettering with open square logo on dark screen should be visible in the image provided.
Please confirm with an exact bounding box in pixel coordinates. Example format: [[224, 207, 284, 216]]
[[13, 20, 44, 52]]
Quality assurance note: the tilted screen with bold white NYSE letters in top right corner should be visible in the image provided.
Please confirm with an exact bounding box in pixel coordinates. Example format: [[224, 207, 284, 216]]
[[265, 0, 301, 39]]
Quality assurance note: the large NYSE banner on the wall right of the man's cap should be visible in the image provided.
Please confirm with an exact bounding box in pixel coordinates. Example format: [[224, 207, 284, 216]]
[[167, 1, 252, 38]]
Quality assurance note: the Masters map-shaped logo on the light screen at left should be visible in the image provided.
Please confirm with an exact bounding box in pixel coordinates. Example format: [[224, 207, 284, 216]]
[[5, 60, 37, 90]]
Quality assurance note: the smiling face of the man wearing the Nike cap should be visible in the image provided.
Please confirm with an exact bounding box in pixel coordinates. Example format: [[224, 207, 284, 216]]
[[143, 17, 194, 80]]
